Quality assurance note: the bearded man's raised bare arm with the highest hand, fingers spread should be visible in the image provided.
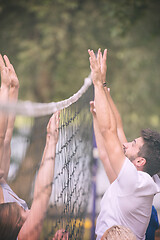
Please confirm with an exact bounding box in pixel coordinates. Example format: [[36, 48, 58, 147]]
[[89, 50, 125, 177]]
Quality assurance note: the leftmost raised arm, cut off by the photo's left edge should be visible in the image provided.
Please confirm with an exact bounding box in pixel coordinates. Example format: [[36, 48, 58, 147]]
[[0, 55, 10, 177]]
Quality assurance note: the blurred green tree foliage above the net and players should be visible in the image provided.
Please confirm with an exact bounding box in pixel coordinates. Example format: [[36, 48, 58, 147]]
[[0, 0, 160, 140]]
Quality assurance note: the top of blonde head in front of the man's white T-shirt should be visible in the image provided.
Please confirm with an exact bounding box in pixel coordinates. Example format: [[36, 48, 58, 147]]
[[101, 225, 136, 240]]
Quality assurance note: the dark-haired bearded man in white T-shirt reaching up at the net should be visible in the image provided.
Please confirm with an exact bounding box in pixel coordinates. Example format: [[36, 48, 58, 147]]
[[88, 49, 160, 240]]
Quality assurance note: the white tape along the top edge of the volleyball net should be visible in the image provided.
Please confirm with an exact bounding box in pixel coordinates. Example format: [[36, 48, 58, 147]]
[[0, 75, 92, 117]]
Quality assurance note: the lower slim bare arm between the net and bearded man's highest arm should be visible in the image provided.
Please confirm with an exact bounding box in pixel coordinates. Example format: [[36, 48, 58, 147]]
[[90, 102, 116, 183]]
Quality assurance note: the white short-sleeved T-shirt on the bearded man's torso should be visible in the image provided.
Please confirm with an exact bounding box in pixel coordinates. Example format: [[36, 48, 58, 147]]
[[96, 159, 157, 240]]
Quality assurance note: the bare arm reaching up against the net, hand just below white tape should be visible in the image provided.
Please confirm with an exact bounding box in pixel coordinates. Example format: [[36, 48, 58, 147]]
[[18, 113, 59, 240]]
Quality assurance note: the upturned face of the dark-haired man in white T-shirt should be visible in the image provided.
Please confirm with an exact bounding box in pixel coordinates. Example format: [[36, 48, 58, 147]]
[[123, 137, 144, 161]]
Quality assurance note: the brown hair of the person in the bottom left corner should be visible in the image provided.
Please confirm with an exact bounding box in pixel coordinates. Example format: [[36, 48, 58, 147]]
[[0, 203, 22, 240]]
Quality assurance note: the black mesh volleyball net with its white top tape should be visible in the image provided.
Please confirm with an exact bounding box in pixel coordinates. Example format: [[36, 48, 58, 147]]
[[0, 76, 93, 240]]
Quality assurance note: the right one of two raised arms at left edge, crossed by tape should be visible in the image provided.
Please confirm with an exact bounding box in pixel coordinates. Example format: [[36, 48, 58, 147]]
[[1, 56, 19, 180]]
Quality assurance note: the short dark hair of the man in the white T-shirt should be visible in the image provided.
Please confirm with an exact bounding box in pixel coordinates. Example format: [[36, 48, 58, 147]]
[[138, 128, 160, 177]]
